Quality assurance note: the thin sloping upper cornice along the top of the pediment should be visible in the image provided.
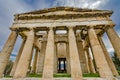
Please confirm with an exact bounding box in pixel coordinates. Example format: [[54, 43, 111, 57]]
[[18, 7, 112, 14]]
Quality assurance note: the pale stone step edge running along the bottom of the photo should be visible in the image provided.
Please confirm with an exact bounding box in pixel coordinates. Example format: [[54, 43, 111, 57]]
[[0, 78, 120, 80]]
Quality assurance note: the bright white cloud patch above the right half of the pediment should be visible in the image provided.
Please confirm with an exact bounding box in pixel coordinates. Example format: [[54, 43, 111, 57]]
[[54, 0, 108, 9]]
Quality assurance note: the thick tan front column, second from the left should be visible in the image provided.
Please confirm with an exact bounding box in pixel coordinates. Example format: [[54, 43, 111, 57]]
[[14, 30, 34, 78]]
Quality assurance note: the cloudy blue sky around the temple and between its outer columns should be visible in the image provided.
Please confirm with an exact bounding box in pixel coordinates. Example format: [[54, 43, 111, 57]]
[[0, 0, 120, 60]]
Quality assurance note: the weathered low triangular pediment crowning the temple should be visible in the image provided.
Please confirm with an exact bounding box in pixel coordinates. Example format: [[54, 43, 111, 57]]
[[15, 7, 112, 20]]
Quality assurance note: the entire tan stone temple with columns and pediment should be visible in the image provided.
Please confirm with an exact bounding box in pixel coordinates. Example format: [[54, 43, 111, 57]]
[[0, 7, 120, 80]]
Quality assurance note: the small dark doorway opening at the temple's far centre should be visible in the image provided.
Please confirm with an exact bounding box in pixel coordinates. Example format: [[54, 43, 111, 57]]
[[58, 58, 67, 73]]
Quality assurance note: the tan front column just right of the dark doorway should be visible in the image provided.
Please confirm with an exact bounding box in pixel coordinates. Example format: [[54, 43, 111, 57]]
[[68, 27, 82, 80]]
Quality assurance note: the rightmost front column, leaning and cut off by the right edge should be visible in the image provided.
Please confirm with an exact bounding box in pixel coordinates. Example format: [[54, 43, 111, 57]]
[[106, 27, 120, 60]]
